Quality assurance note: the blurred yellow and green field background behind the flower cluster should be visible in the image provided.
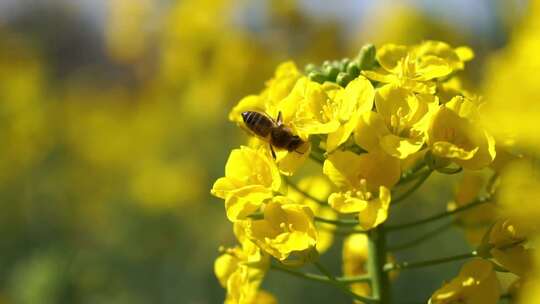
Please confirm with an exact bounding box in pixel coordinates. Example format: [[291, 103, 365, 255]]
[[0, 0, 528, 304]]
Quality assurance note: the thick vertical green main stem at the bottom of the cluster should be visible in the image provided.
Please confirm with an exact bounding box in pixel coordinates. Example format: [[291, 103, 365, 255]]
[[367, 225, 390, 304]]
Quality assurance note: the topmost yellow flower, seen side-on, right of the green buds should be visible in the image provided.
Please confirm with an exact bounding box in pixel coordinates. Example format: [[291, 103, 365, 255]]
[[362, 41, 472, 94]]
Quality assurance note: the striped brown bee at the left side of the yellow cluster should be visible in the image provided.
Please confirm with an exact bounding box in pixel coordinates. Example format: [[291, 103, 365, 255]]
[[242, 111, 304, 159]]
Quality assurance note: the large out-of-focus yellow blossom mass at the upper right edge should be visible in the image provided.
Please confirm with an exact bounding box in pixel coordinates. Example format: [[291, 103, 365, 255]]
[[483, 0, 540, 151]]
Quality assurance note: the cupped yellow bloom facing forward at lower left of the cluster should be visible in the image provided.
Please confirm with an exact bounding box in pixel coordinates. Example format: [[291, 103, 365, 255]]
[[246, 196, 317, 266]]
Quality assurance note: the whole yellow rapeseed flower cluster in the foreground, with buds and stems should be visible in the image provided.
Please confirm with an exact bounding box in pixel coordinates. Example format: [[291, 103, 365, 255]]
[[211, 41, 532, 303]]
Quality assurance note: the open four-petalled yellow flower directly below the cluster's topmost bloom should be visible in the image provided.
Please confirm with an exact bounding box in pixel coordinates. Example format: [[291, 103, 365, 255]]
[[355, 85, 438, 159]]
